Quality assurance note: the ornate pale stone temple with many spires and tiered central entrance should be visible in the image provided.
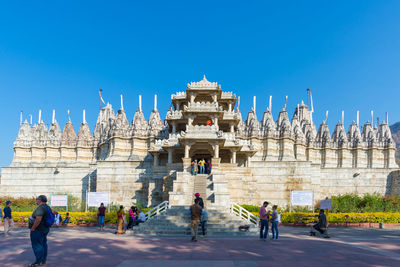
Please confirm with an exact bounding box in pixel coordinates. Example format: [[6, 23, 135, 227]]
[[0, 76, 400, 206]]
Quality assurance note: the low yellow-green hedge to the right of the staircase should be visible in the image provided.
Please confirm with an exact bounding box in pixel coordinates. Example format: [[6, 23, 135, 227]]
[[252, 212, 400, 223]]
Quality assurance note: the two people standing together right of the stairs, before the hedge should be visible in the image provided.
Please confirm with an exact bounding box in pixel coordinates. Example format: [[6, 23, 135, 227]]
[[259, 201, 280, 241]]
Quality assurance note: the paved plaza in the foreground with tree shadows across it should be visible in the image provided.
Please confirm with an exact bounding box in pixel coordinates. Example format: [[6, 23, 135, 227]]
[[0, 227, 400, 267]]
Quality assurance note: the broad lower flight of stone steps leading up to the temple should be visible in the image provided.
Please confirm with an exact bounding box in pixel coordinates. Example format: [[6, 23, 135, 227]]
[[131, 206, 259, 236]]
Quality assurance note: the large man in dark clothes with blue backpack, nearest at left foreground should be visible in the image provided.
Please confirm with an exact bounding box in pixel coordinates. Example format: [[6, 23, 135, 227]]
[[29, 195, 52, 266]]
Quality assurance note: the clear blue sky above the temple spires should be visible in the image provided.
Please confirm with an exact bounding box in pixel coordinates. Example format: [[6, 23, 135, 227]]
[[0, 0, 400, 166]]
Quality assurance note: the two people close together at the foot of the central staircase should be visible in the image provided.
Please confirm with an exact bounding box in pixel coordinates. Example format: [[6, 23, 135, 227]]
[[189, 193, 208, 242]]
